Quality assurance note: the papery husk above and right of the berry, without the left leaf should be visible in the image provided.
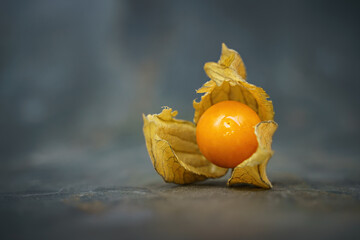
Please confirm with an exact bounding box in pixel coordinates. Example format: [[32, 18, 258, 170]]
[[193, 44, 277, 188]]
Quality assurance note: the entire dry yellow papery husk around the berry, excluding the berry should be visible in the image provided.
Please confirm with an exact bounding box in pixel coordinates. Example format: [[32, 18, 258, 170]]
[[143, 44, 277, 188]]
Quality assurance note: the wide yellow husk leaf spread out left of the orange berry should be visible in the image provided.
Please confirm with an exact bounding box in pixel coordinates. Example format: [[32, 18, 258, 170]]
[[143, 108, 227, 184]]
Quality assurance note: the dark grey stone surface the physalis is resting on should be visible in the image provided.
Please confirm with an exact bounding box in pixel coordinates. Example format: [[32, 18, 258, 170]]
[[0, 143, 360, 239]]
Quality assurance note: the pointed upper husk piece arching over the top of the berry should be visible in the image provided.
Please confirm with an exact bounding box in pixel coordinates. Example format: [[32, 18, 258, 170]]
[[193, 44, 274, 123]]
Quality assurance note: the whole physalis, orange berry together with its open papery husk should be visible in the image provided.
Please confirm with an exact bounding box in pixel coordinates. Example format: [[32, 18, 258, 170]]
[[143, 44, 277, 188]]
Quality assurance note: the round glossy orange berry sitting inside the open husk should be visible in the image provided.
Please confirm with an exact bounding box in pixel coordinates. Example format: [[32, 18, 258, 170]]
[[196, 101, 261, 168]]
